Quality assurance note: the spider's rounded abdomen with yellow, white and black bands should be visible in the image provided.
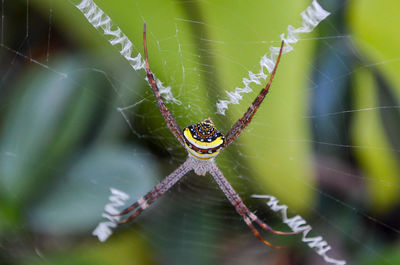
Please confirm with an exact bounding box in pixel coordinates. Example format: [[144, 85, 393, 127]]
[[183, 118, 225, 160]]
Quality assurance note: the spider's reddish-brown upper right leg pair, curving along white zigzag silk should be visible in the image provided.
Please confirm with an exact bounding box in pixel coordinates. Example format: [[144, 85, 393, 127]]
[[224, 41, 284, 147]]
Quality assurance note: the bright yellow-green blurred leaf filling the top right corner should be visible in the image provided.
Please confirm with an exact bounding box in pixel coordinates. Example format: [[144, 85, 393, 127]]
[[348, 0, 400, 92]]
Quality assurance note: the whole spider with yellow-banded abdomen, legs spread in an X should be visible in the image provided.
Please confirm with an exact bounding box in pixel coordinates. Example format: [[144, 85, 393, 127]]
[[116, 24, 302, 248]]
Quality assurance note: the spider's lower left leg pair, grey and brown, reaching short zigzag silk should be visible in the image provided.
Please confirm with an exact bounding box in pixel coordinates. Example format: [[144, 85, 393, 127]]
[[116, 158, 192, 224]]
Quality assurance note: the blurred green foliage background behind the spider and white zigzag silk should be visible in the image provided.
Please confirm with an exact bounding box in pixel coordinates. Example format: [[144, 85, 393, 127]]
[[0, 0, 400, 265]]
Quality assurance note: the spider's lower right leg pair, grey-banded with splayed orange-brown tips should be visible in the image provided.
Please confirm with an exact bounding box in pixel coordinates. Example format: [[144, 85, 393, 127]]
[[210, 164, 302, 248]]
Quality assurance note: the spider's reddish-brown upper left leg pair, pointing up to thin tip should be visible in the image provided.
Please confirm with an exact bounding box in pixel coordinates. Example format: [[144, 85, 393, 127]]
[[143, 24, 185, 146]]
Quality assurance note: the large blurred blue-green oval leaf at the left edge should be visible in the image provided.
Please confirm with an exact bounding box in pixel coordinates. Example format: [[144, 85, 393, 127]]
[[0, 61, 94, 202]]
